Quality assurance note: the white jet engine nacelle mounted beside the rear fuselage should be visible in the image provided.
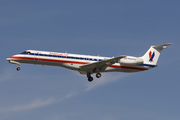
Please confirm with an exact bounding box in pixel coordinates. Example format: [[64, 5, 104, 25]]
[[119, 56, 144, 66]]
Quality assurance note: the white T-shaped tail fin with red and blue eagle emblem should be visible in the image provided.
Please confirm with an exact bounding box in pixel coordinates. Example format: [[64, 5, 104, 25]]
[[141, 43, 172, 65]]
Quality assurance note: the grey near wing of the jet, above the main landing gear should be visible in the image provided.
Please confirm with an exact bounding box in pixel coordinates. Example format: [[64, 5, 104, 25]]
[[80, 56, 126, 72]]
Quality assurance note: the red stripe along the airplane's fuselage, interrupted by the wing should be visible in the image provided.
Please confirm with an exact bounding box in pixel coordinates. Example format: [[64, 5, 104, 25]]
[[9, 56, 148, 71]]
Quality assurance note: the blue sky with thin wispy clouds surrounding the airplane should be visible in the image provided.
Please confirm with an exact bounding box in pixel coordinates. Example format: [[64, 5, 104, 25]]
[[0, 0, 180, 120]]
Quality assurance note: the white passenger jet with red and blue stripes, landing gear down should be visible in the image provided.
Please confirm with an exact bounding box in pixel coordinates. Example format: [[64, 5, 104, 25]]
[[6, 43, 172, 82]]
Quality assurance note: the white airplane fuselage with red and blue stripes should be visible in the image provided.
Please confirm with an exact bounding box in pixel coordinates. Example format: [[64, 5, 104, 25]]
[[6, 50, 152, 74]]
